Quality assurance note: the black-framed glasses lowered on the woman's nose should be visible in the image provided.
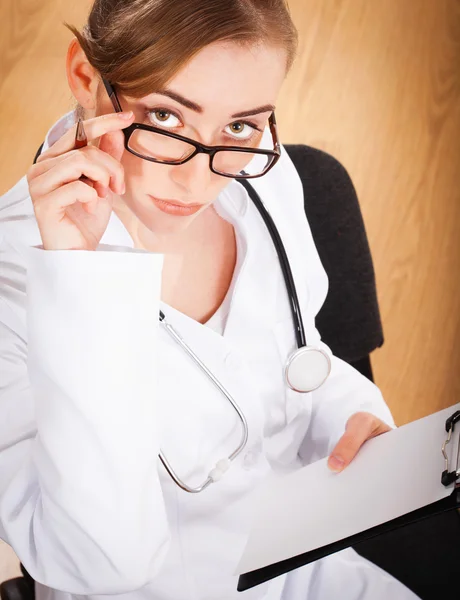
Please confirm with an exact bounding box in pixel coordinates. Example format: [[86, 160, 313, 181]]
[[102, 77, 281, 179]]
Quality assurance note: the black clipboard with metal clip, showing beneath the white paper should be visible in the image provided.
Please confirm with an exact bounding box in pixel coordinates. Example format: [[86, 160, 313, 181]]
[[237, 410, 460, 592]]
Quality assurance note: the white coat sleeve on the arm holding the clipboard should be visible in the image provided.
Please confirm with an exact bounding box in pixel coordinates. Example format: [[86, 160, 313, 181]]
[[299, 334, 395, 464]]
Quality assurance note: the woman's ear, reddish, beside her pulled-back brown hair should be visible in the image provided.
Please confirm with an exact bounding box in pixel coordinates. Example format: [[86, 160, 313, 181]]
[[66, 38, 99, 116]]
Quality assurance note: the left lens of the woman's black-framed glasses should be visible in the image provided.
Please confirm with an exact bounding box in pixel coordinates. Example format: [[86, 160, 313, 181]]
[[128, 129, 195, 161]]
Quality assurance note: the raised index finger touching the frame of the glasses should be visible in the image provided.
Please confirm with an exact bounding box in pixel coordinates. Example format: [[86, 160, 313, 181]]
[[37, 111, 134, 162]]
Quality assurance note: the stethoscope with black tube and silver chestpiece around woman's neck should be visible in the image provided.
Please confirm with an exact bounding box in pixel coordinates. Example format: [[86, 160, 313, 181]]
[[34, 144, 332, 494]]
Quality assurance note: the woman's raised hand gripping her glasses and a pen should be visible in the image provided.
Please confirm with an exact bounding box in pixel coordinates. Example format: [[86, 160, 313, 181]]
[[27, 112, 134, 250]]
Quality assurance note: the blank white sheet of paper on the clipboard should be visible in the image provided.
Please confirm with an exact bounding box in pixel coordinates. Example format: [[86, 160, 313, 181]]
[[236, 403, 460, 575]]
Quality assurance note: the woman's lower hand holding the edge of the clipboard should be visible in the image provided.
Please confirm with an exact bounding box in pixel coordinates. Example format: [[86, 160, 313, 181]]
[[327, 412, 391, 473]]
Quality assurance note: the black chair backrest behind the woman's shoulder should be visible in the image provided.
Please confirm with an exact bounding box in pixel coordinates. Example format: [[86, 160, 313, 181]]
[[285, 144, 384, 370]]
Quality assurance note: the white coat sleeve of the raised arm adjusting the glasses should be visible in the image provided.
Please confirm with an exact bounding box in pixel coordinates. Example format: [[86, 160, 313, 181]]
[[0, 246, 170, 596]]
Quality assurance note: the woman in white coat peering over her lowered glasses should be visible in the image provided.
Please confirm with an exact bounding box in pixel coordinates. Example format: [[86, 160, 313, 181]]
[[0, 0, 415, 600]]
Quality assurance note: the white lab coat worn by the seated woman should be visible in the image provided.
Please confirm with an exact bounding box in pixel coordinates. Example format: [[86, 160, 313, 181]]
[[0, 113, 415, 600]]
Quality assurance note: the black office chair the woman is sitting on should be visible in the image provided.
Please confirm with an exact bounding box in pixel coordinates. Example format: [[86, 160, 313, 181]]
[[0, 145, 460, 600]]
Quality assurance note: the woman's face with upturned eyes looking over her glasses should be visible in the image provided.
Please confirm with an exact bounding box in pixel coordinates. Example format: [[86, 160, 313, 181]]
[[97, 43, 286, 243]]
